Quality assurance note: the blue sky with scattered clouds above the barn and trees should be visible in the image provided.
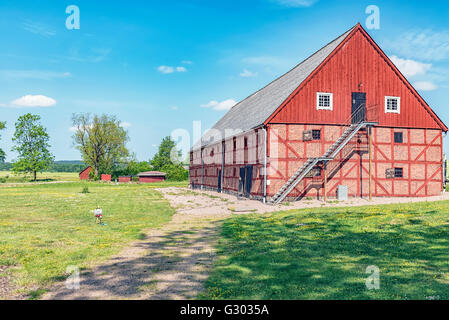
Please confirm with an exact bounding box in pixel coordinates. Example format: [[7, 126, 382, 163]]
[[0, 0, 449, 160]]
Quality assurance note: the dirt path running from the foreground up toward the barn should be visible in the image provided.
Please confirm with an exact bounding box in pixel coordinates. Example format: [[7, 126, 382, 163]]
[[43, 188, 231, 300]]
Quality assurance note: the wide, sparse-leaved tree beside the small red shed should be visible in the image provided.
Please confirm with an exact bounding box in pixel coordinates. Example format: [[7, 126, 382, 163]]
[[72, 113, 129, 178]]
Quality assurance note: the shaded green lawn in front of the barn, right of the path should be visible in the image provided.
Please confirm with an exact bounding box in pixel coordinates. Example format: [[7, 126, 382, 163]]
[[200, 201, 449, 299]]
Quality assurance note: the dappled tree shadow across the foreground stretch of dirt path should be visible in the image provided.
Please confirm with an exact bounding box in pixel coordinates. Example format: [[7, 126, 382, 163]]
[[45, 222, 219, 300]]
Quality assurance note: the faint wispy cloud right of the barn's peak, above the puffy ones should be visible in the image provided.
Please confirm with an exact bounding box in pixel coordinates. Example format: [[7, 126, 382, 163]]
[[384, 30, 449, 61]]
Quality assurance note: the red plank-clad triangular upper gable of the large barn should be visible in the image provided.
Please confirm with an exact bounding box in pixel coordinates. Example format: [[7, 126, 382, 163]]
[[270, 28, 441, 129]]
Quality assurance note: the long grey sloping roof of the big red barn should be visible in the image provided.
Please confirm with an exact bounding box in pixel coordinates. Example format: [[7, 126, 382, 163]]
[[193, 26, 356, 149]]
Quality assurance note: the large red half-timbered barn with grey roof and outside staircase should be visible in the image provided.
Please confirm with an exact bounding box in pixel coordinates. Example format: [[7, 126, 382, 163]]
[[190, 24, 447, 203]]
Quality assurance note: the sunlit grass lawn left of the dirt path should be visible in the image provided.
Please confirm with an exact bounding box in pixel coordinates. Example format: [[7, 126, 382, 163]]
[[0, 182, 186, 298]]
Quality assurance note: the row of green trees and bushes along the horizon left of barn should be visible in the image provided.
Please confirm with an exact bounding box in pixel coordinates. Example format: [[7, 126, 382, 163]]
[[0, 113, 188, 181]]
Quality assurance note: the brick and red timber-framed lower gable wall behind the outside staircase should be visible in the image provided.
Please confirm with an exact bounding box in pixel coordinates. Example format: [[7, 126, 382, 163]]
[[268, 124, 443, 199]]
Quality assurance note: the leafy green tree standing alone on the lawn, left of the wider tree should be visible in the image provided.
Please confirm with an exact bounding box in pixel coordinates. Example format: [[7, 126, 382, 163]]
[[12, 113, 54, 181]]
